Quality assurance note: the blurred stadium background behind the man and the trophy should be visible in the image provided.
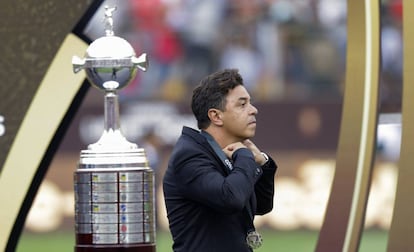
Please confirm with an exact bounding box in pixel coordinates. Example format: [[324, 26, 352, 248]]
[[18, 0, 403, 252]]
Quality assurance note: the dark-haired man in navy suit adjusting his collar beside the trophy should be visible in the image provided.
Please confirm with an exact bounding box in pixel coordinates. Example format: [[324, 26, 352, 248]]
[[163, 69, 277, 252]]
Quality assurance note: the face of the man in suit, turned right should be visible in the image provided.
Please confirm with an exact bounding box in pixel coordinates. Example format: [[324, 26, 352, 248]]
[[222, 85, 258, 141]]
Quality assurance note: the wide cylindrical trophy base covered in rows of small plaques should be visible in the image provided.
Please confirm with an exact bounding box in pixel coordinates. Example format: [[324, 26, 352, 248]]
[[74, 149, 155, 252]]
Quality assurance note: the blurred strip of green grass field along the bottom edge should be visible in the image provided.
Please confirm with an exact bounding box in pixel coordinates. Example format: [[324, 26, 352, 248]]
[[16, 230, 387, 252]]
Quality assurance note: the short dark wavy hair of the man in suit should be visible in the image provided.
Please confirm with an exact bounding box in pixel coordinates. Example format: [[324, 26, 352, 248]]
[[191, 69, 243, 129]]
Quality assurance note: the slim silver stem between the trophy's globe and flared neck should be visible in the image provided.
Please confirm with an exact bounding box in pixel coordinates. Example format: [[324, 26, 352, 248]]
[[104, 91, 120, 131]]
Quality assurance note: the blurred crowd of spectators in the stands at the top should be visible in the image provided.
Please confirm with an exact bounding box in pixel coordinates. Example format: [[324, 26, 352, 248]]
[[87, 0, 402, 105]]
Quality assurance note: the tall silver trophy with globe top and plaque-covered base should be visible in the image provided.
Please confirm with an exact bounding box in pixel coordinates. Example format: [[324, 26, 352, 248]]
[[72, 6, 155, 252]]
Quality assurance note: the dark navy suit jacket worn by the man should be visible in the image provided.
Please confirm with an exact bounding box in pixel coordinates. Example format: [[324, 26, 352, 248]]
[[163, 127, 277, 252]]
